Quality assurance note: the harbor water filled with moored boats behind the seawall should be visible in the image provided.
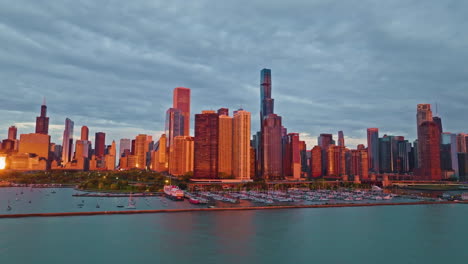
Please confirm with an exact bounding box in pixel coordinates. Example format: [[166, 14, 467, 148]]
[[0, 187, 467, 215]]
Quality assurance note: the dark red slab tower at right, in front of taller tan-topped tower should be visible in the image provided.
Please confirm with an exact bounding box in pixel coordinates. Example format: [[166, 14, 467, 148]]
[[418, 121, 442, 181]]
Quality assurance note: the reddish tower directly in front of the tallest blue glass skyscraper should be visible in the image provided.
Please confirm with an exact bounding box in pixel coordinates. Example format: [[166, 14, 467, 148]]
[[262, 114, 283, 180]]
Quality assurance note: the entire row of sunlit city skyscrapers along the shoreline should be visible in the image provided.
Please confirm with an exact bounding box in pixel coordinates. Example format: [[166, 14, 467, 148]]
[[0, 69, 468, 181]]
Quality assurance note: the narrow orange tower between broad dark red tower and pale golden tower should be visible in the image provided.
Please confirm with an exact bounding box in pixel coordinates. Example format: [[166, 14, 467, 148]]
[[218, 114, 233, 177]]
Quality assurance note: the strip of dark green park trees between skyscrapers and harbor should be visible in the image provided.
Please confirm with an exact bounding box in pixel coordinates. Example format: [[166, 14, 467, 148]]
[[0, 170, 378, 192]]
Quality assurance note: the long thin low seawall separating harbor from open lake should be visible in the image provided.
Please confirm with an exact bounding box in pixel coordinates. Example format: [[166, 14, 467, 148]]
[[0, 201, 468, 218]]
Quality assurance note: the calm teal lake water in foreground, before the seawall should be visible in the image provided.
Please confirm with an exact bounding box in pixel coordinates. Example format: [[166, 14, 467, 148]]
[[0, 189, 468, 264]]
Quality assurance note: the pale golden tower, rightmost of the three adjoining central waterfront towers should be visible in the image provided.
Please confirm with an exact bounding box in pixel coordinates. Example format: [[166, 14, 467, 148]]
[[232, 109, 250, 180]]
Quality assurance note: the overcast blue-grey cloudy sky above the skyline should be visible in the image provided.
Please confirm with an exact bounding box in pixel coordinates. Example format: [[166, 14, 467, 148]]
[[0, 0, 468, 148]]
